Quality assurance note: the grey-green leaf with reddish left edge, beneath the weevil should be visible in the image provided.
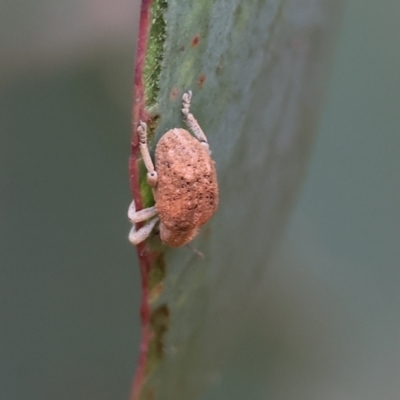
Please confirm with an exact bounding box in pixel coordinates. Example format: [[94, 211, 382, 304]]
[[130, 0, 343, 400]]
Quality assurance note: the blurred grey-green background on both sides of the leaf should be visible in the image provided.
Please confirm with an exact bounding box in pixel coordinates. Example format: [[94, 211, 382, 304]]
[[0, 0, 400, 400]]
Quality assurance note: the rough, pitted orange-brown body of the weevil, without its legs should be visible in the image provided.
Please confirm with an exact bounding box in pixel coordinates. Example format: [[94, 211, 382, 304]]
[[155, 129, 218, 247]]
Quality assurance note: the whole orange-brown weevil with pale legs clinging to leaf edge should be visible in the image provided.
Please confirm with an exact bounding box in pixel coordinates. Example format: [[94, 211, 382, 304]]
[[128, 91, 218, 247]]
